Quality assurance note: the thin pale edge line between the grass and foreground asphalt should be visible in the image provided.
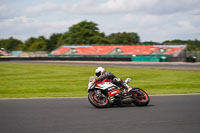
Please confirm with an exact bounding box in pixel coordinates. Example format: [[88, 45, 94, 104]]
[[0, 93, 200, 100]]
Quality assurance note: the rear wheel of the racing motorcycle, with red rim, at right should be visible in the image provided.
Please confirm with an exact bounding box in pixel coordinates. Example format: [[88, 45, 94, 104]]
[[131, 88, 150, 106]]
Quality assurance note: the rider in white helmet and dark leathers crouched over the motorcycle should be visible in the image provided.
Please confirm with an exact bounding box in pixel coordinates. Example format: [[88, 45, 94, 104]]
[[95, 67, 128, 90]]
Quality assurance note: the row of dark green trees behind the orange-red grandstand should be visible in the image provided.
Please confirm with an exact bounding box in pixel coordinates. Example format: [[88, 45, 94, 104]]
[[0, 21, 200, 51]]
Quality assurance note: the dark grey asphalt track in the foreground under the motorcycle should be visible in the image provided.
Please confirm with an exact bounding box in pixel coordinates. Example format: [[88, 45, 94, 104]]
[[0, 94, 200, 133]]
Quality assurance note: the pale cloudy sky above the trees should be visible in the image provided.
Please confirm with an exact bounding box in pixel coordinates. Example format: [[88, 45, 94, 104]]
[[0, 0, 200, 42]]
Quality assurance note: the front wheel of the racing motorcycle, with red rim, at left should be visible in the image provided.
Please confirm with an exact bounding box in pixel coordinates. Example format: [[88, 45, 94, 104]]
[[88, 90, 109, 108]]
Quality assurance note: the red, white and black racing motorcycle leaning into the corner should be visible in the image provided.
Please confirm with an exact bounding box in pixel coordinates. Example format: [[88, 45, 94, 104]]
[[88, 76, 150, 108]]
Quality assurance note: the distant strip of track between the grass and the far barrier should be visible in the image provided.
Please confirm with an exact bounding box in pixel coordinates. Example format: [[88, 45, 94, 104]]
[[0, 61, 200, 71]]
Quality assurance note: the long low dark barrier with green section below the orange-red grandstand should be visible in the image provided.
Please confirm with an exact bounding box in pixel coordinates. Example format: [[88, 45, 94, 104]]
[[0, 55, 196, 62]]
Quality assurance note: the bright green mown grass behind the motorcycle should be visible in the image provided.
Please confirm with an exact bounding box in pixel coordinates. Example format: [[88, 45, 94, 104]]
[[0, 63, 200, 98]]
